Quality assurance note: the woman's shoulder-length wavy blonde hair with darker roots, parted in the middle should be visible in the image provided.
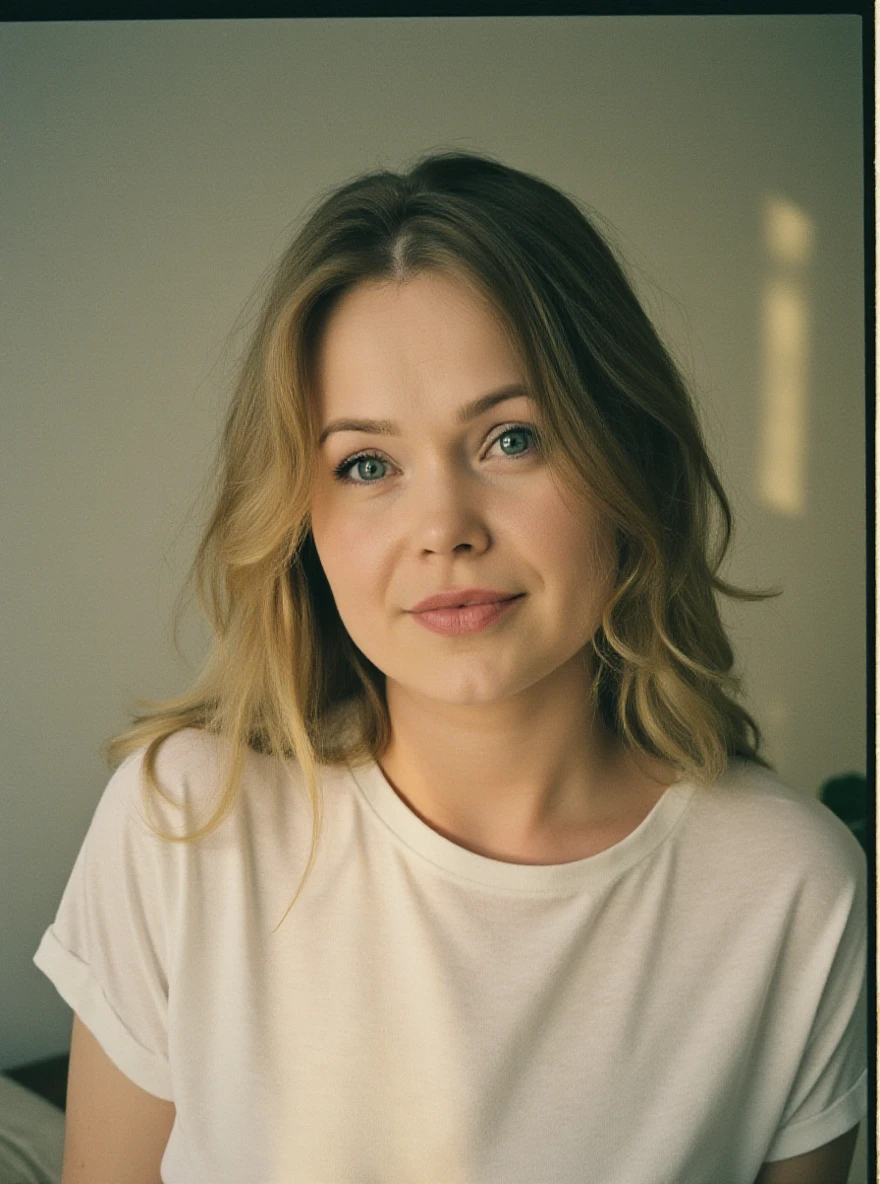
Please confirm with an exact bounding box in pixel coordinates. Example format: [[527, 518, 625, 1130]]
[[103, 152, 779, 920]]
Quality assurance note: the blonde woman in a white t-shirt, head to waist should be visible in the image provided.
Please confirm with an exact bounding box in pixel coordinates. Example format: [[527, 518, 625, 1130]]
[[34, 153, 867, 1184]]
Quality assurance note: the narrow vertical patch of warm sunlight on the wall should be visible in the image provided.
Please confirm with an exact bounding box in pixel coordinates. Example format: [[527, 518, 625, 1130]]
[[757, 195, 815, 517]]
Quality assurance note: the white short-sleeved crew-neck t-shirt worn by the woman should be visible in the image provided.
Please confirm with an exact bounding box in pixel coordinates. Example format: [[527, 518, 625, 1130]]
[[33, 729, 867, 1184]]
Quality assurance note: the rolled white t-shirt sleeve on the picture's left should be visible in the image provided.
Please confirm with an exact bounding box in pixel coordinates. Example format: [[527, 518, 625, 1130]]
[[33, 749, 173, 1101]]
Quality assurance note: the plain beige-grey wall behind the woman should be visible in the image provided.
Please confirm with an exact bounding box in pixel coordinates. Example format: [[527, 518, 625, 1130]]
[[0, 15, 866, 1160]]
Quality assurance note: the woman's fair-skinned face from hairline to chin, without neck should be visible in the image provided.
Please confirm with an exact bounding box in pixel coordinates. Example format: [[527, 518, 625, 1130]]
[[311, 272, 615, 704]]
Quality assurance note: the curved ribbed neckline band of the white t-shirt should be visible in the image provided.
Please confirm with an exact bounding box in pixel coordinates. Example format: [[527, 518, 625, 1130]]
[[348, 760, 696, 895]]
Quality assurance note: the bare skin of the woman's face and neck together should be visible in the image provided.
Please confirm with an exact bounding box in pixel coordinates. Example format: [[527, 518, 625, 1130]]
[[311, 272, 675, 863]]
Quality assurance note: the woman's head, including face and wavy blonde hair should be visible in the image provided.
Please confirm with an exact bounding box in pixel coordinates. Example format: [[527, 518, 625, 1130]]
[[108, 143, 769, 923]]
